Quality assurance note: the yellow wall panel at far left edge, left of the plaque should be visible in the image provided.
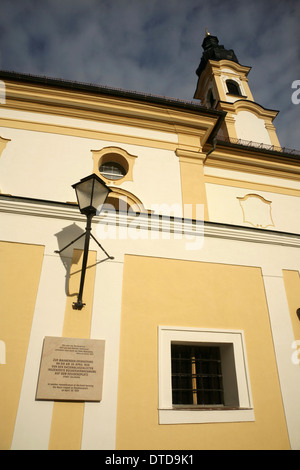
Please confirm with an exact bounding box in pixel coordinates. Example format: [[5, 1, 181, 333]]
[[0, 242, 44, 450]]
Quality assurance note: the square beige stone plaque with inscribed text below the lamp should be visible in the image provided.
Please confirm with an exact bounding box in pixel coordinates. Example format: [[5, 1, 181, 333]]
[[36, 336, 105, 401]]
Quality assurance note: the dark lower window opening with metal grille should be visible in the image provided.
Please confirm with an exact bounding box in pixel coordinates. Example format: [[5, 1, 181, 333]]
[[171, 343, 224, 406]]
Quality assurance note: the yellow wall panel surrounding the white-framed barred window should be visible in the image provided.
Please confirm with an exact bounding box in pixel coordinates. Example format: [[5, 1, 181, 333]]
[[116, 256, 290, 450]]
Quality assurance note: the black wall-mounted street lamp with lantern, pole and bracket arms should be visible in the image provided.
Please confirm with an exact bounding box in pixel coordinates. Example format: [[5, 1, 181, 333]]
[[55, 174, 114, 310]]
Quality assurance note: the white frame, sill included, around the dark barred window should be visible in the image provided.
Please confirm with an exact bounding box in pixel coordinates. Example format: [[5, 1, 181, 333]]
[[158, 326, 255, 424]]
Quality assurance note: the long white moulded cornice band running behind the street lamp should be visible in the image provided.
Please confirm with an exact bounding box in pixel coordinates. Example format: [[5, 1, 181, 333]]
[[0, 197, 300, 248]]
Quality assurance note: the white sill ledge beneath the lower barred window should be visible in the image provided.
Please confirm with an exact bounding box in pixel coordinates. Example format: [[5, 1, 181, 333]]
[[159, 406, 255, 424]]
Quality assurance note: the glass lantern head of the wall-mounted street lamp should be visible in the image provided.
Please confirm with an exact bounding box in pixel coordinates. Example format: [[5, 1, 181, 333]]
[[72, 174, 111, 215]]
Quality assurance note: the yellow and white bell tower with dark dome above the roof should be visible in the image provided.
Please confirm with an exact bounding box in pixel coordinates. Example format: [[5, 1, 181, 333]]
[[194, 31, 280, 147]]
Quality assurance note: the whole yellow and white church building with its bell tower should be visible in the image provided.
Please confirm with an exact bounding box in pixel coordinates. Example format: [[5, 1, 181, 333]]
[[0, 32, 300, 451]]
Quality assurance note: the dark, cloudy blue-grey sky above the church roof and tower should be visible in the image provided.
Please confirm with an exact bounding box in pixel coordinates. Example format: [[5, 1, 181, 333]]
[[0, 0, 300, 149]]
